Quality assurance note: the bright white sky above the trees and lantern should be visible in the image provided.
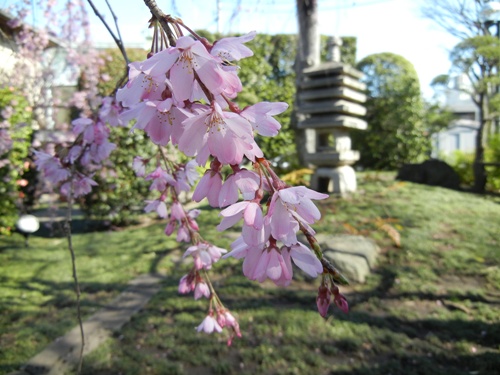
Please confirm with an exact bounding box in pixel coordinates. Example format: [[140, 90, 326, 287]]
[[0, 0, 458, 98]]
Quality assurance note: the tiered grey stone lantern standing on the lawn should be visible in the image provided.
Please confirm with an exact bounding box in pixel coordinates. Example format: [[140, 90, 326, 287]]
[[298, 38, 367, 194]]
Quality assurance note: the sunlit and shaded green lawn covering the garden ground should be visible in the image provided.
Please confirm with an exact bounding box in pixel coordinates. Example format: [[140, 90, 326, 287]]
[[0, 173, 500, 375]]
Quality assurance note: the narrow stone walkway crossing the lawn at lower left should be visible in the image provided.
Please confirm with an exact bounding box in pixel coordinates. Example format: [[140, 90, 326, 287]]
[[9, 274, 163, 375]]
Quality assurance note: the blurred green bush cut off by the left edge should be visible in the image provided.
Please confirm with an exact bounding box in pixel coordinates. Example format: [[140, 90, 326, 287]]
[[0, 87, 33, 234]]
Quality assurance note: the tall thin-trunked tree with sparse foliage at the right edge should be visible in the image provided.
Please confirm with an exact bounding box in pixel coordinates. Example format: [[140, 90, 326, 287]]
[[423, 0, 500, 192]]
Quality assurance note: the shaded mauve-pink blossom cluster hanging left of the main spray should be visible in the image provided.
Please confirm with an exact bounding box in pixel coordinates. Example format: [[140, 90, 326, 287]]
[[34, 97, 121, 197]]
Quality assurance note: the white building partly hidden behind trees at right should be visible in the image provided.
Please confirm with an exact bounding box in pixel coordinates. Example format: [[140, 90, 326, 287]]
[[432, 76, 479, 158]]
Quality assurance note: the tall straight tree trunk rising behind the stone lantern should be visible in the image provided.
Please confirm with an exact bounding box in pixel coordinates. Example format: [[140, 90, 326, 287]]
[[291, 0, 320, 165]]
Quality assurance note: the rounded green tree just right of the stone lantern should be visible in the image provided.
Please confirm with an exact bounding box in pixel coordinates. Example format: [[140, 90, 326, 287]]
[[353, 53, 431, 169]]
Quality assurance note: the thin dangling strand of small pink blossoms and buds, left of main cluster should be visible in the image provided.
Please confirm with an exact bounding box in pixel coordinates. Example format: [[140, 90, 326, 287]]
[[133, 139, 241, 345]]
